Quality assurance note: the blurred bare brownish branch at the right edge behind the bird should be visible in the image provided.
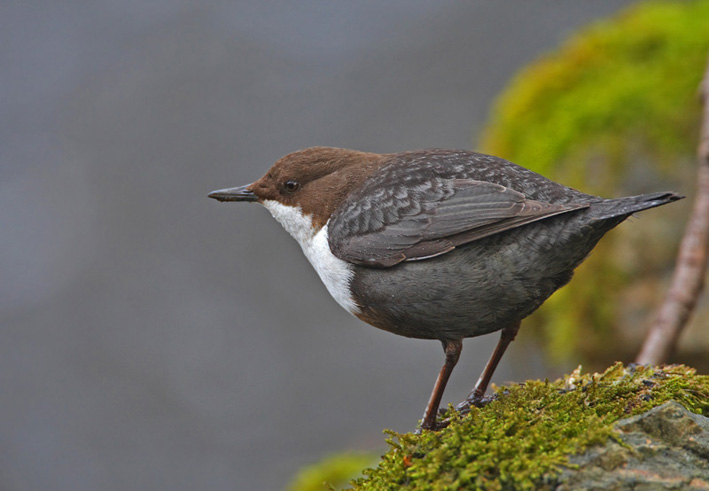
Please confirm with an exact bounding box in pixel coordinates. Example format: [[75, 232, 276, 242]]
[[636, 55, 709, 365]]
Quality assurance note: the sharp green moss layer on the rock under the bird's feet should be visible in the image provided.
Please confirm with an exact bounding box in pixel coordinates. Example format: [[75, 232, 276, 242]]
[[350, 363, 709, 491]]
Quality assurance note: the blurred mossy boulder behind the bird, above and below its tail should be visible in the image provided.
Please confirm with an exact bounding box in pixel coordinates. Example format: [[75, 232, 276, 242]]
[[478, 0, 709, 366]]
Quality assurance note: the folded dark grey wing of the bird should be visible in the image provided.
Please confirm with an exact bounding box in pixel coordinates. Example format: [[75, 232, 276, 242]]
[[328, 169, 588, 267]]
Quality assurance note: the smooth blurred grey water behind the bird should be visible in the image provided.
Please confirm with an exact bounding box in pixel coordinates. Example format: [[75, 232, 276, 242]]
[[0, 0, 627, 491]]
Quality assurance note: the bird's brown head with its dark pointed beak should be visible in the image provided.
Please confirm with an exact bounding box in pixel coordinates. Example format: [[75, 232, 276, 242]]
[[209, 147, 384, 228]]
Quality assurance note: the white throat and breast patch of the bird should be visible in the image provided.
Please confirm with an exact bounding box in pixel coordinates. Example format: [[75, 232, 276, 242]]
[[263, 200, 360, 314]]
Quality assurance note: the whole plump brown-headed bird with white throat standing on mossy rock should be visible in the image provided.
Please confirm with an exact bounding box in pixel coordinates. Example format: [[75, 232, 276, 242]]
[[209, 147, 682, 429]]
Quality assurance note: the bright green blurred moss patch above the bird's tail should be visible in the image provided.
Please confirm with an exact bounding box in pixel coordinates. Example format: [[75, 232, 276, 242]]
[[481, 1, 709, 177]]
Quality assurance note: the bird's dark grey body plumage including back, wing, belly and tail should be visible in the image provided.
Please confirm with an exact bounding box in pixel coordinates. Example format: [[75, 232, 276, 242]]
[[329, 150, 679, 341]]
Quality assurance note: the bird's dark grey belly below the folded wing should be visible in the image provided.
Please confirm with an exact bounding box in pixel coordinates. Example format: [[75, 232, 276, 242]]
[[351, 219, 602, 339]]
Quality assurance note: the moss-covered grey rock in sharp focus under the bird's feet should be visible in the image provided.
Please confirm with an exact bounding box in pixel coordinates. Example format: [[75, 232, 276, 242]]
[[344, 364, 709, 491]]
